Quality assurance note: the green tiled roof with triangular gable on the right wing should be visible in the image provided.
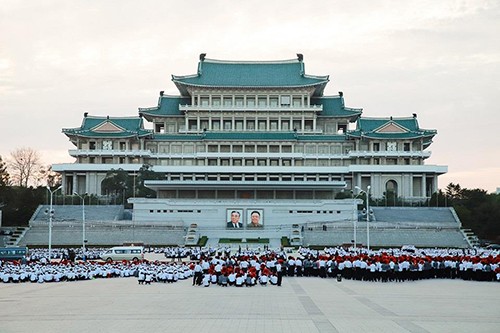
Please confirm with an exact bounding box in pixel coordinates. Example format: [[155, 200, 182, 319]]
[[348, 117, 437, 145]]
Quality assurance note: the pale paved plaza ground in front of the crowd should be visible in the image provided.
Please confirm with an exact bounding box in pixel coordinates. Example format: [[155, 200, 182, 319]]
[[0, 277, 500, 333]]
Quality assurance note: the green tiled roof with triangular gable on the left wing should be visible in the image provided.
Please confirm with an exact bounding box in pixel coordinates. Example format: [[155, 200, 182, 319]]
[[62, 115, 152, 138]]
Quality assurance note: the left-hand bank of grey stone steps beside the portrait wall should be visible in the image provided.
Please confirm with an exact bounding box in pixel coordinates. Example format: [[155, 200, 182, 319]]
[[16, 205, 185, 247]]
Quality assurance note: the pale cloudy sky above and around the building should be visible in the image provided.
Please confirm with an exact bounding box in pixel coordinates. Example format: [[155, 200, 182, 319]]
[[0, 0, 500, 192]]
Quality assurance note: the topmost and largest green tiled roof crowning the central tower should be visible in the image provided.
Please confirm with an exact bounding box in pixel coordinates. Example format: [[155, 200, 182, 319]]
[[172, 59, 329, 96]]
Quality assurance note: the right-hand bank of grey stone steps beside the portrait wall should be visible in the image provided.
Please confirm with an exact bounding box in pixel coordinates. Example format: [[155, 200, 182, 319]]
[[304, 207, 475, 248]]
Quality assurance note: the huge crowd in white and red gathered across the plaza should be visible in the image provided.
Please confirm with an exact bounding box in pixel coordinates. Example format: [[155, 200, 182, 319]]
[[0, 247, 500, 287]]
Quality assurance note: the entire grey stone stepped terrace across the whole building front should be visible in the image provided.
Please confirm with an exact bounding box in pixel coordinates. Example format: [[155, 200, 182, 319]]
[[15, 206, 477, 248]]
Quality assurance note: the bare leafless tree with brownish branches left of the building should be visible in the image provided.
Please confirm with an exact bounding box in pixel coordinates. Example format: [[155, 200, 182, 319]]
[[8, 147, 41, 187]]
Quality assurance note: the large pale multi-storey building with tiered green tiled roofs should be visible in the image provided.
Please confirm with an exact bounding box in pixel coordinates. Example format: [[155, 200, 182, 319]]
[[53, 54, 447, 231]]
